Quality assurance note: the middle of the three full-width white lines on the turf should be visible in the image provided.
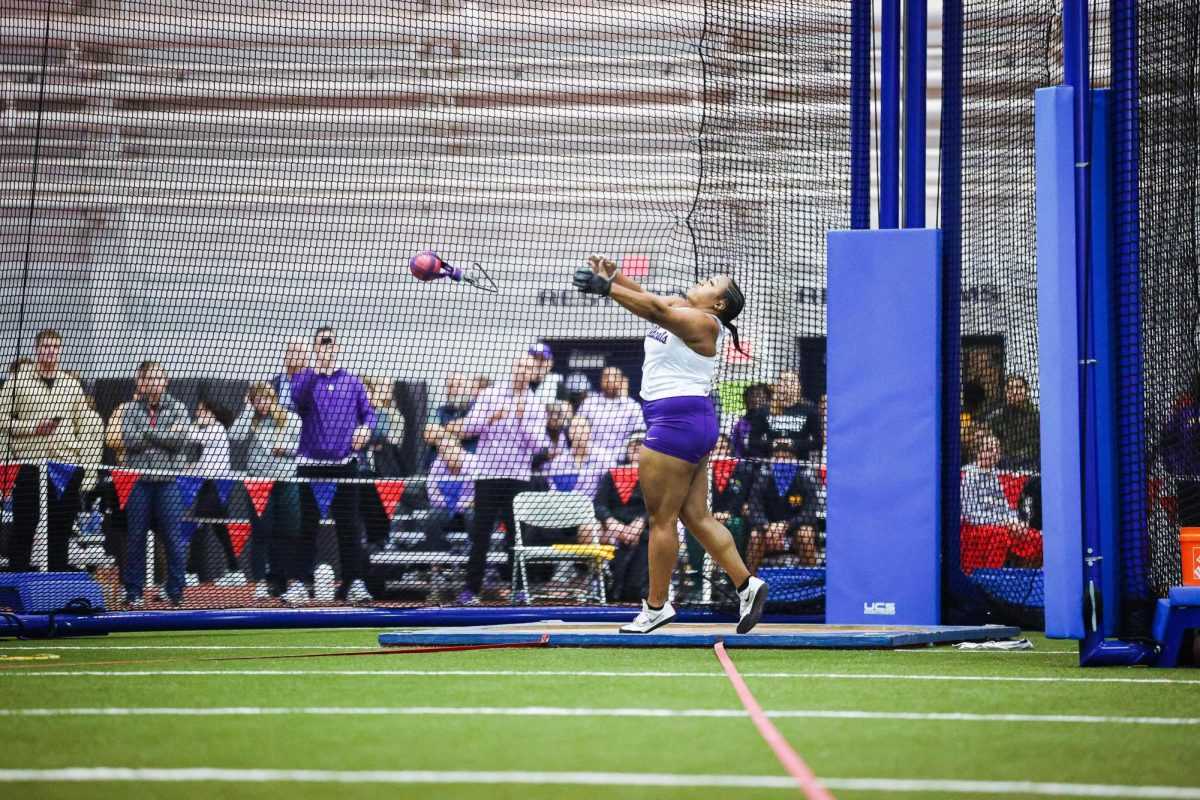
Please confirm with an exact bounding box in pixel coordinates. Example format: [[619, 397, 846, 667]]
[[0, 705, 1200, 726]]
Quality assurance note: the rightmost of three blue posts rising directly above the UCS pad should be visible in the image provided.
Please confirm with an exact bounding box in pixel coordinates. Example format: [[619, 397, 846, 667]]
[[904, 0, 929, 228]]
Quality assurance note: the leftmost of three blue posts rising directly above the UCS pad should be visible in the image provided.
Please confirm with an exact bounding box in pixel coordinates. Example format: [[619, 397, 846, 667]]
[[850, 0, 871, 230]]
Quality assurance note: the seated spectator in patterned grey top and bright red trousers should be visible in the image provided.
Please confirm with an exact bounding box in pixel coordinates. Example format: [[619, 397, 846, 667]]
[[961, 432, 1042, 572]]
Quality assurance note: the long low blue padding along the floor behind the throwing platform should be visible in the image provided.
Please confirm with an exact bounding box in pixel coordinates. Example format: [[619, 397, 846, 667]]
[[0, 606, 821, 637]]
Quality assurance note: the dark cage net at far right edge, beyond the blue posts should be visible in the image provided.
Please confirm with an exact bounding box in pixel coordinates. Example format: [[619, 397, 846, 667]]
[[1112, 2, 1200, 637]]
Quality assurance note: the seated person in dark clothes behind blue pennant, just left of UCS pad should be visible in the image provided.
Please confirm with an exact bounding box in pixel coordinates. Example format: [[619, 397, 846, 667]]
[[746, 437, 821, 572]]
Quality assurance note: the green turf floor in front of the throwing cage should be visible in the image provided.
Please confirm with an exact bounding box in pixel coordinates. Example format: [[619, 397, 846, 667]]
[[0, 631, 1200, 800]]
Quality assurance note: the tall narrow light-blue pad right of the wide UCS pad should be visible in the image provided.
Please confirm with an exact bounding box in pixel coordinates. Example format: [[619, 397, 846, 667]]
[[1032, 86, 1084, 639]]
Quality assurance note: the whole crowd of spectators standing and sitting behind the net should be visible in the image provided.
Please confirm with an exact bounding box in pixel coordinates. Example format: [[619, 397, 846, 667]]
[[0, 327, 1040, 607]]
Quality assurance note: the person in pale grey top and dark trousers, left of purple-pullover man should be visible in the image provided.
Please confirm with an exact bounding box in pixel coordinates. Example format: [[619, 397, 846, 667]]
[[229, 381, 305, 599]]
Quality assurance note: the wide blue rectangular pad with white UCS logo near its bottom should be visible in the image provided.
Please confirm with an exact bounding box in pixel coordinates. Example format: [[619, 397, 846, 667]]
[[826, 229, 942, 625]]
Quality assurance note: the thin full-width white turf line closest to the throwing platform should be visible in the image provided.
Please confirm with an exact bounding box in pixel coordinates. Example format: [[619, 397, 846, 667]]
[[0, 664, 1200, 686]]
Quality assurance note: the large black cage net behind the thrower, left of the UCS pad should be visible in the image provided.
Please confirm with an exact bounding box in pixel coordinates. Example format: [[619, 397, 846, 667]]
[[0, 0, 850, 610]]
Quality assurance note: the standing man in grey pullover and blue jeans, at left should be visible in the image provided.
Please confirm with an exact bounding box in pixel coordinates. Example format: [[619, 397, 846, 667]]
[[120, 361, 192, 607]]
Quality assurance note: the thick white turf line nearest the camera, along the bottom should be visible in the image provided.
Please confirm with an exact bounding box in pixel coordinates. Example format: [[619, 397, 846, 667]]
[[0, 766, 1200, 800]]
